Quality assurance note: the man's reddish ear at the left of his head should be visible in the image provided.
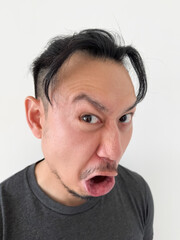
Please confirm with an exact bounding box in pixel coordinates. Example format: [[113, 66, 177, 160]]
[[25, 97, 44, 138]]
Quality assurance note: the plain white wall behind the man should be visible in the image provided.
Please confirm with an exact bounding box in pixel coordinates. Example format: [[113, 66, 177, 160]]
[[0, 0, 180, 240]]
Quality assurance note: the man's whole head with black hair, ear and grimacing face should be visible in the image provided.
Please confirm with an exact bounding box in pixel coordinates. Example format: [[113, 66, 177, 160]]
[[26, 30, 147, 204]]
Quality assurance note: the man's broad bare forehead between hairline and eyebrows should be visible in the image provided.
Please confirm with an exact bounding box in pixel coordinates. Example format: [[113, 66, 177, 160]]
[[52, 52, 135, 108]]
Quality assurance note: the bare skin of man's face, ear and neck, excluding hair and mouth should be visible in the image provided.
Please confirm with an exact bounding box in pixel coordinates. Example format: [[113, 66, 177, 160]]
[[25, 53, 136, 206]]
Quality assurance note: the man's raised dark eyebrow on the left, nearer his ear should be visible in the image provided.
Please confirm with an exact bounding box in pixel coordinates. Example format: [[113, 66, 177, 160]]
[[72, 93, 109, 112]]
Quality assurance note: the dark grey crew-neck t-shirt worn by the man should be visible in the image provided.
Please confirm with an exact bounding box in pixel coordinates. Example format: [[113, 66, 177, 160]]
[[0, 160, 153, 240]]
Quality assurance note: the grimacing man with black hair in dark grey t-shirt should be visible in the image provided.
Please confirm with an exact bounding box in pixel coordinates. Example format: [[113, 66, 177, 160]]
[[0, 29, 153, 240]]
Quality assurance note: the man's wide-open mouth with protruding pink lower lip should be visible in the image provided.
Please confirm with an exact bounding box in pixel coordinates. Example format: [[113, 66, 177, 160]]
[[85, 176, 115, 197]]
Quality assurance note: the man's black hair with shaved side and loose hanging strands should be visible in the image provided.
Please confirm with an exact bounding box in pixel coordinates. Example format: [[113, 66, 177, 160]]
[[32, 29, 147, 104]]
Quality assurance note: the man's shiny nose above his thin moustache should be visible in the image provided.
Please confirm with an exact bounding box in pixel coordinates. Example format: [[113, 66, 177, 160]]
[[97, 124, 123, 161]]
